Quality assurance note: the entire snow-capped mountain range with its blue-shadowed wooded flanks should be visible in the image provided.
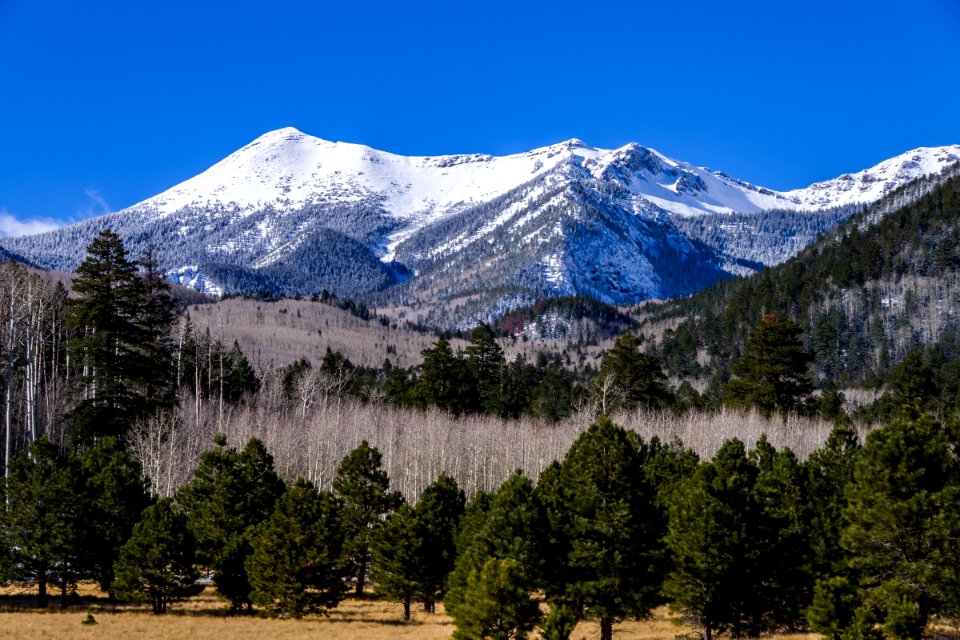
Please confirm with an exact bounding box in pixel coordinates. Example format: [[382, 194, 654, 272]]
[[2, 128, 960, 319]]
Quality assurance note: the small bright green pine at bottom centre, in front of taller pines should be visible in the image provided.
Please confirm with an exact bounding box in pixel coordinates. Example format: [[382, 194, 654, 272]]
[[450, 558, 540, 640]]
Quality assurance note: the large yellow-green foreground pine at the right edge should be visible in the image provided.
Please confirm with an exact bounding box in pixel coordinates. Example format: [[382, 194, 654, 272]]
[[842, 417, 960, 640]]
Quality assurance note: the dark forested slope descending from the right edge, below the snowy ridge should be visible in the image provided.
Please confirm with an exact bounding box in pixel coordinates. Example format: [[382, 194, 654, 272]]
[[642, 169, 960, 385]]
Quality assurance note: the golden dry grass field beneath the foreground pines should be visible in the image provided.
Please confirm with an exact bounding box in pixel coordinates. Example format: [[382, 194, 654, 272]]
[[0, 587, 816, 640]]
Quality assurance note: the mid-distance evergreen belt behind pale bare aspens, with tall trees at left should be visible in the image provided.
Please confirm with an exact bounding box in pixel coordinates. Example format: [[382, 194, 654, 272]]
[[0, 231, 892, 469]]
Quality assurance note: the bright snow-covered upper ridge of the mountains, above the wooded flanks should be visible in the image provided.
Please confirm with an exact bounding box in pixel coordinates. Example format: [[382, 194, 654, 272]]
[[142, 127, 960, 221]]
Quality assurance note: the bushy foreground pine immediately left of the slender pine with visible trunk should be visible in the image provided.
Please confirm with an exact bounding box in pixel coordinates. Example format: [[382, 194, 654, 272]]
[[246, 478, 350, 618]]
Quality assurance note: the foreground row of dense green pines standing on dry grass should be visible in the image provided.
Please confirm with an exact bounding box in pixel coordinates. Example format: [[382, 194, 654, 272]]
[[0, 416, 960, 640]]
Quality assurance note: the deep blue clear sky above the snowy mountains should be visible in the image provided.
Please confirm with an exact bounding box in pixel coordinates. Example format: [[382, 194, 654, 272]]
[[0, 0, 960, 233]]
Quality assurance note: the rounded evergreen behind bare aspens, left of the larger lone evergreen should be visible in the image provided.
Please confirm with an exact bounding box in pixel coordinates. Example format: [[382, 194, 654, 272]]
[[594, 332, 673, 414]]
